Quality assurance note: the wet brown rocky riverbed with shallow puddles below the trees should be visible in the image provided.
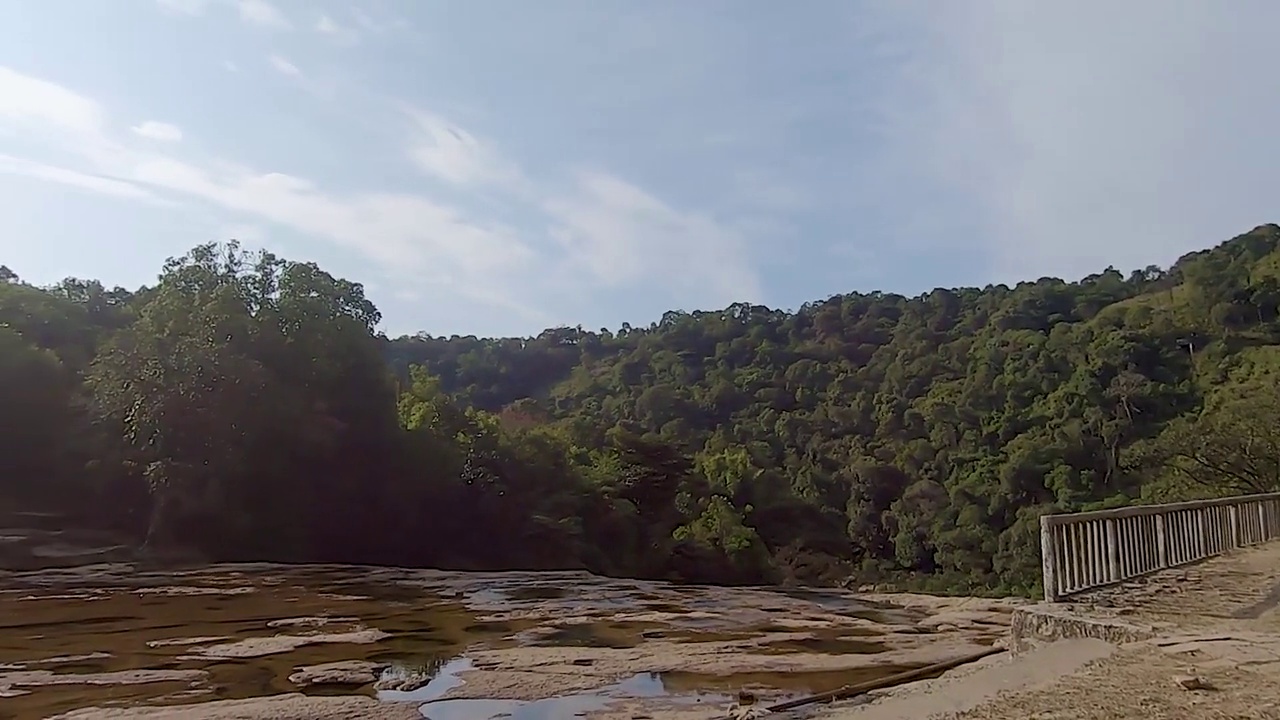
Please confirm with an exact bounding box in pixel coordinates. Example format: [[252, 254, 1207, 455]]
[[0, 564, 1016, 720]]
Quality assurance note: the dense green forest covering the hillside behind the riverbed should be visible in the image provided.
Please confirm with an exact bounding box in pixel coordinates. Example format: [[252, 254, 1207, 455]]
[[0, 225, 1280, 592]]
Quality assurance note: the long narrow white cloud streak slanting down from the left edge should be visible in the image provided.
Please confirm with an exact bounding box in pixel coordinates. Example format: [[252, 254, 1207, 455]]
[[0, 68, 538, 315]]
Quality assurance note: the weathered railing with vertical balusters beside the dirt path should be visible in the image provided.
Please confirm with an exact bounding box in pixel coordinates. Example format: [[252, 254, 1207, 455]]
[[1041, 492, 1280, 602]]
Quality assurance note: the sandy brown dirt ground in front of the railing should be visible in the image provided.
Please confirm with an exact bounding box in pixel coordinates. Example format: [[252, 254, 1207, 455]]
[[815, 543, 1280, 720]]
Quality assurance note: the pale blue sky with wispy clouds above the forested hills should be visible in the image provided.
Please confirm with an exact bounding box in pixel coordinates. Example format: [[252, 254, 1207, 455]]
[[0, 0, 1280, 336]]
